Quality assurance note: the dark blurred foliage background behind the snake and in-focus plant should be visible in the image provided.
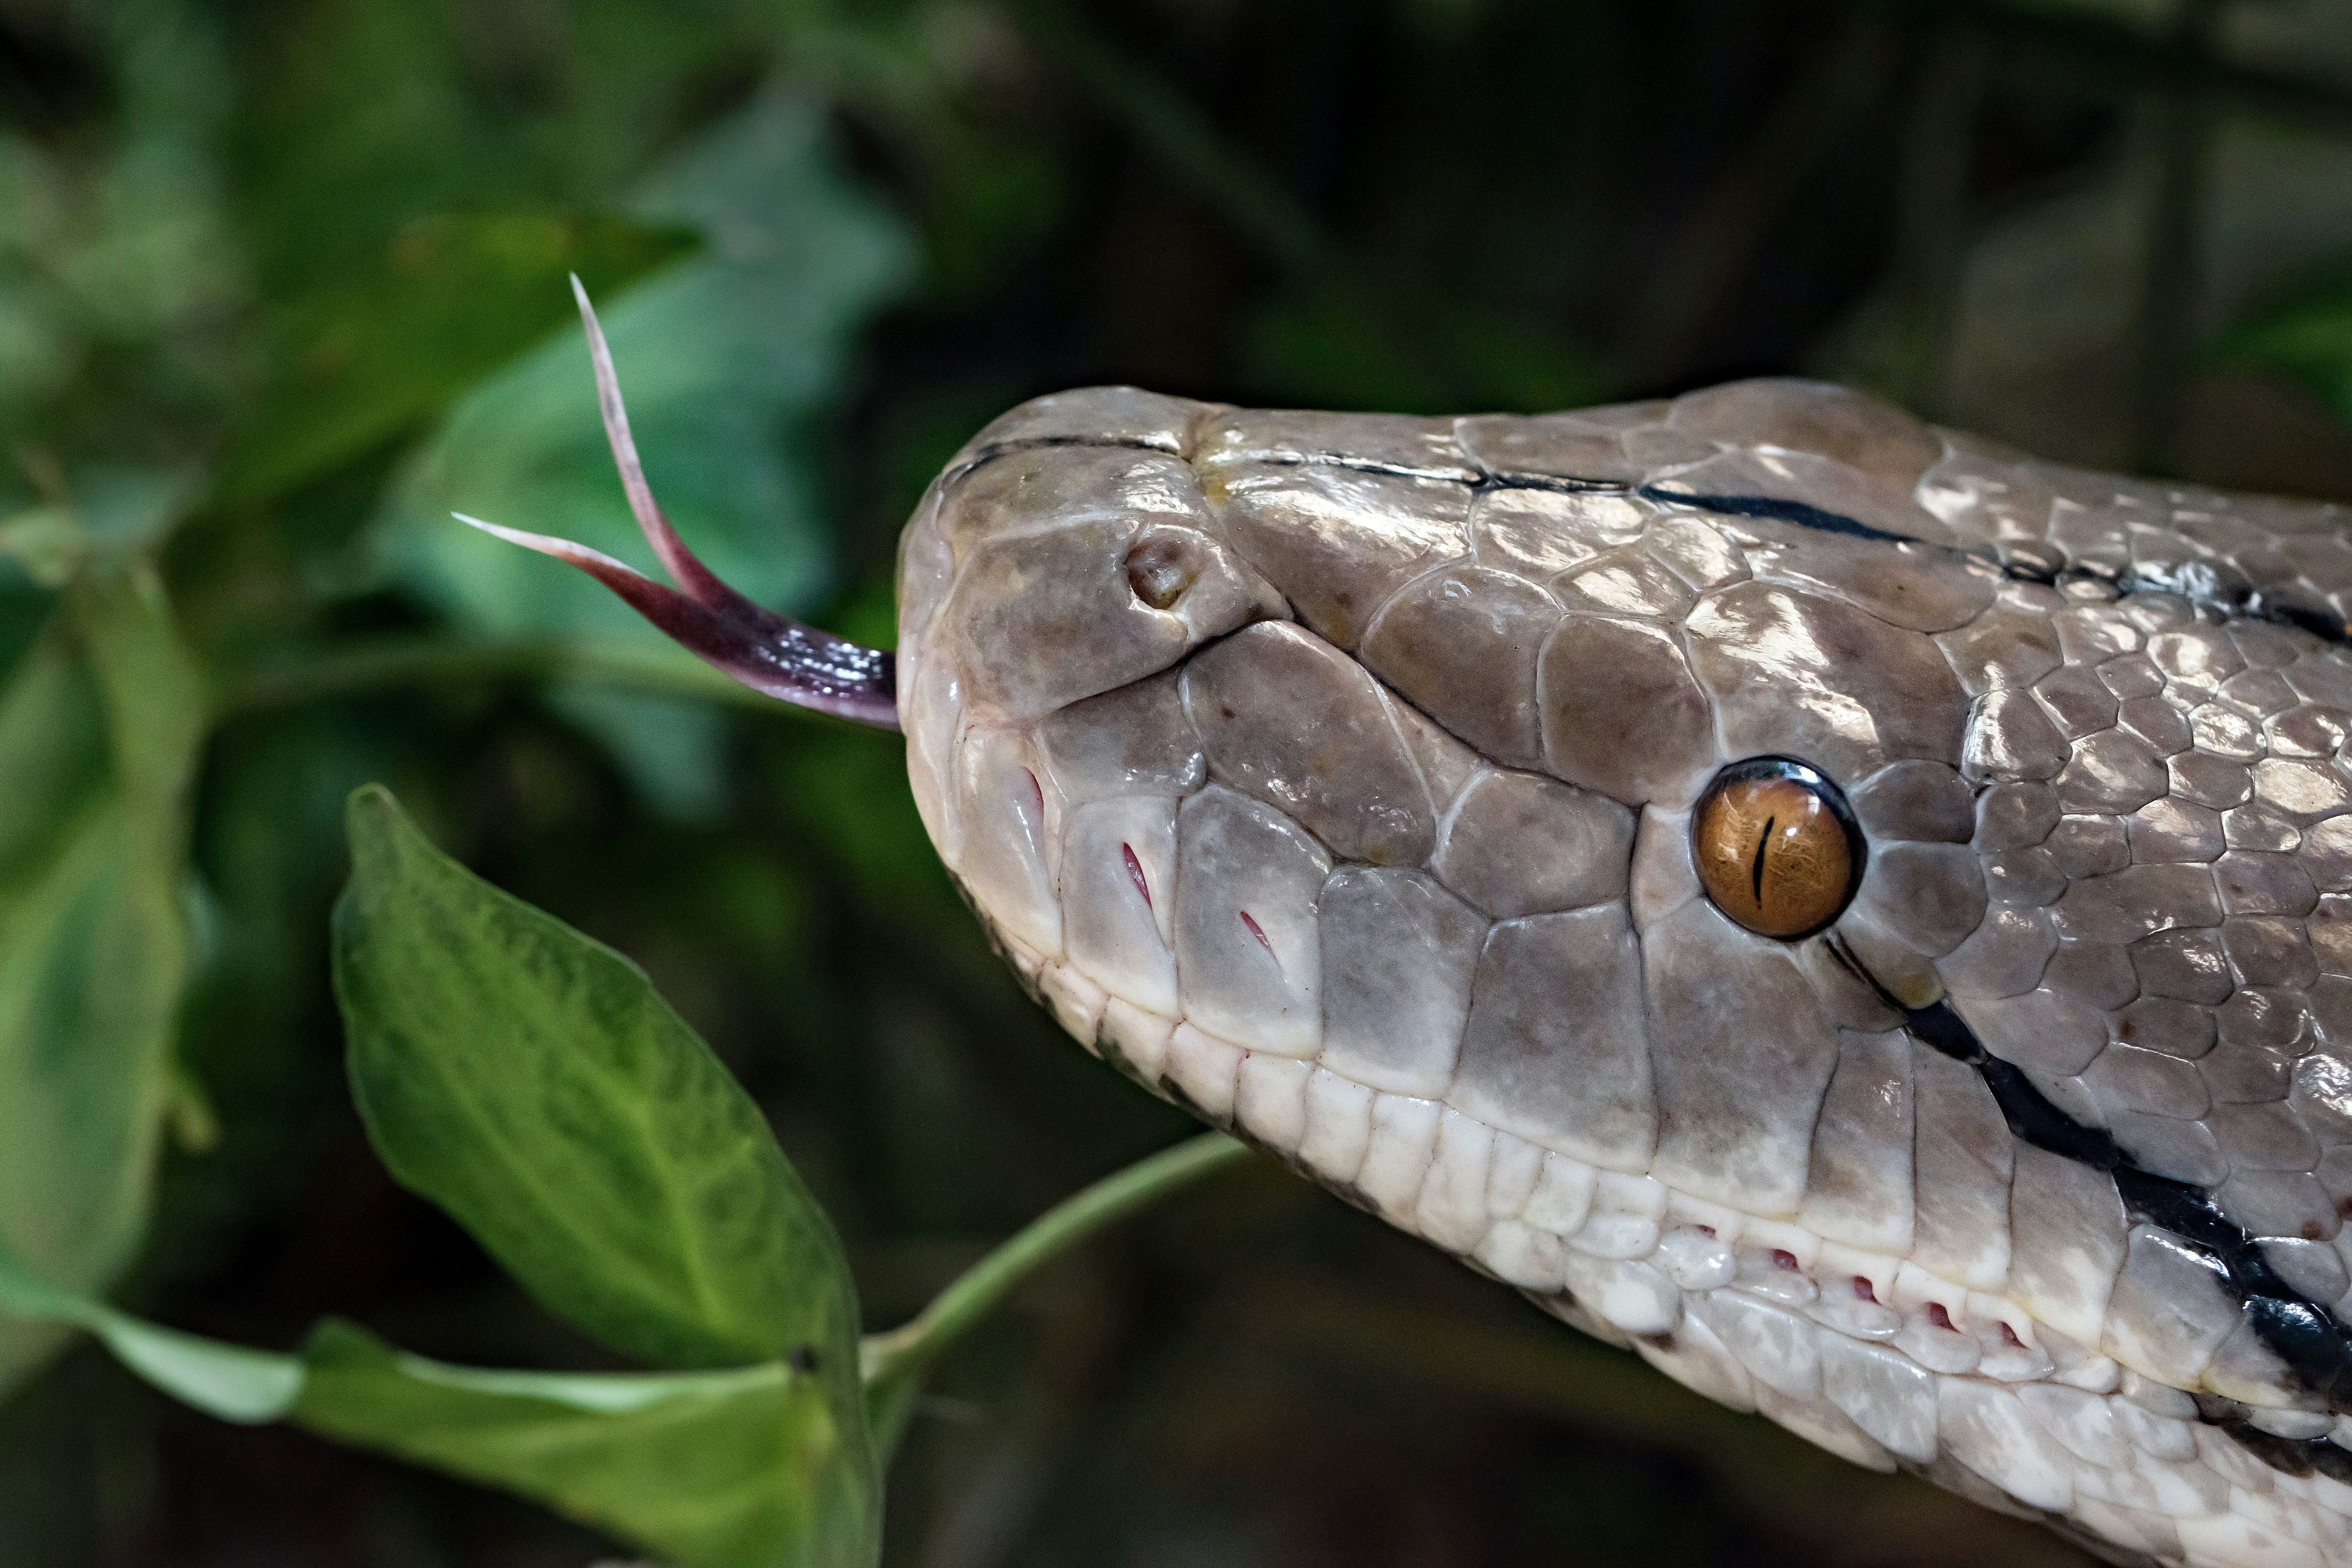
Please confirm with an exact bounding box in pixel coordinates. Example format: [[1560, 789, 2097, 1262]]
[[0, 0, 2352, 1568]]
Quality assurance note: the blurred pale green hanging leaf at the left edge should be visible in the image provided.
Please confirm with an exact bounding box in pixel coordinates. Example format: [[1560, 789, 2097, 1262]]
[[0, 559, 202, 1387]]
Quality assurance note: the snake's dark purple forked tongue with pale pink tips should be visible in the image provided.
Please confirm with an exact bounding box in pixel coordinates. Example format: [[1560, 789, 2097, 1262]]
[[451, 278, 898, 729]]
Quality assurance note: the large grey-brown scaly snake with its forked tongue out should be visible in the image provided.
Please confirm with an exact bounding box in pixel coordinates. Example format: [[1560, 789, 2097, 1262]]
[[482, 285, 2352, 1568]]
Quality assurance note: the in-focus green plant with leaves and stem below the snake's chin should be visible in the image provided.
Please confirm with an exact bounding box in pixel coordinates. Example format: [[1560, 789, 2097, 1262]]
[[0, 785, 1249, 1568]]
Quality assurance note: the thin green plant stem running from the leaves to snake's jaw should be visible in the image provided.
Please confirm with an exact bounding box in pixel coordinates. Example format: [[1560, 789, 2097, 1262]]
[[861, 1133, 1249, 1389]]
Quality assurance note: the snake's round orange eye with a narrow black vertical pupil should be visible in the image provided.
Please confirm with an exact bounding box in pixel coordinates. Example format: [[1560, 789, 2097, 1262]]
[[1691, 757, 1863, 943]]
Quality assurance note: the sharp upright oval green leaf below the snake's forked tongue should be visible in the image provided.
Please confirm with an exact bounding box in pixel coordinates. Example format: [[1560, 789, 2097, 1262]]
[[334, 785, 856, 1399]]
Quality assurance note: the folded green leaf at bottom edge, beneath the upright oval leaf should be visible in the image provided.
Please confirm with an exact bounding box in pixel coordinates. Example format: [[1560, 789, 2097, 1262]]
[[294, 1324, 880, 1568]]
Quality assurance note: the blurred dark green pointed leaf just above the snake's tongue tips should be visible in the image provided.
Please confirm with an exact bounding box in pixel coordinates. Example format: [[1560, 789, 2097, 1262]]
[[221, 212, 694, 501]]
